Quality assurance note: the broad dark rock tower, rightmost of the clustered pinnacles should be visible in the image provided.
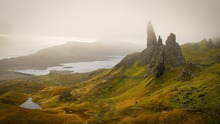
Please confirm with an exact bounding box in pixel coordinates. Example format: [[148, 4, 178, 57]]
[[165, 33, 186, 66]]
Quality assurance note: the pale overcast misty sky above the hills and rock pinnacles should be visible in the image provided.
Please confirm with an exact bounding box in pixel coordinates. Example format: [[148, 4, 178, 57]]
[[0, 0, 220, 43]]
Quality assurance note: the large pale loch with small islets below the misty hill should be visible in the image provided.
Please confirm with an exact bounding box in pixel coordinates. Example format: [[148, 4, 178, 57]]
[[15, 56, 123, 76]]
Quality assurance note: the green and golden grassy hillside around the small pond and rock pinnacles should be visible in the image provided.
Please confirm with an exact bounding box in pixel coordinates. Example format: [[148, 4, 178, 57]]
[[0, 42, 220, 124]]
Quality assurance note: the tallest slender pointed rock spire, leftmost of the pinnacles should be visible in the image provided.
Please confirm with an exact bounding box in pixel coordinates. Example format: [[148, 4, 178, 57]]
[[147, 21, 157, 47]]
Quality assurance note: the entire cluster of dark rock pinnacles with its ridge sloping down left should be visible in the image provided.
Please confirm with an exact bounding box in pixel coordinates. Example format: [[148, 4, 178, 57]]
[[115, 22, 186, 78]]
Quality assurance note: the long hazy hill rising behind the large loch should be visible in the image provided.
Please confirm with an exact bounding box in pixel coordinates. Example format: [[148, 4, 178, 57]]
[[0, 41, 141, 80]]
